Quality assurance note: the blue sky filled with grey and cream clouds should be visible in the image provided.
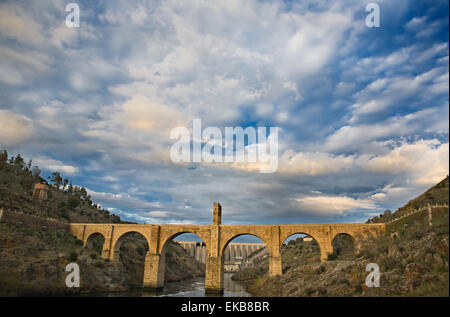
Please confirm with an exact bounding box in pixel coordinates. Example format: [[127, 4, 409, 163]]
[[0, 0, 449, 224]]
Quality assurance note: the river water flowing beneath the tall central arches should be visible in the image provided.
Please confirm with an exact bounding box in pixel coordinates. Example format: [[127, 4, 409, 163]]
[[101, 273, 252, 297]]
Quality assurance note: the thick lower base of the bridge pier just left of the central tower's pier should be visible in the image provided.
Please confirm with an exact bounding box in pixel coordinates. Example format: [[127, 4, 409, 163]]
[[142, 252, 166, 291]]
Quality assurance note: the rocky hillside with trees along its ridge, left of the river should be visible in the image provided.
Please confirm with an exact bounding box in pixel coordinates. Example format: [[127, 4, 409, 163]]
[[0, 153, 205, 296]]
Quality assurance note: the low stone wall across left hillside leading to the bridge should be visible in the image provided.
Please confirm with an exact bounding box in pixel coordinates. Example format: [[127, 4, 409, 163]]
[[0, 209, 70, 232]]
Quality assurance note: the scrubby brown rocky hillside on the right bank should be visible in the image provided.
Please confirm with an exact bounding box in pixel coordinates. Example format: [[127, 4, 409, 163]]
[[233, 178, 449, 296]]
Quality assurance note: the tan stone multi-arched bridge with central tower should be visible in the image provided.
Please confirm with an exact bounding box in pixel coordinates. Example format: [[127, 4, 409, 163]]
[[70, 203, 385, 293]]
